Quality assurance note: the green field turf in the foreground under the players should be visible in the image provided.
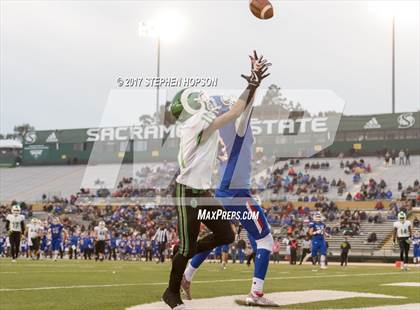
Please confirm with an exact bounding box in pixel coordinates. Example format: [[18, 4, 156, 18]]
[[0, 259, 420, 310]]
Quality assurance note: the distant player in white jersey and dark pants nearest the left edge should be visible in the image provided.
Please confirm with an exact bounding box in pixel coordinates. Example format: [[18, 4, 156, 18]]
[[6, 205, 25, 262]]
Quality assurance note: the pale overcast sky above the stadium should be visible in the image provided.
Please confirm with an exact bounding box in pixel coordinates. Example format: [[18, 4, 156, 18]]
[[0, 0, 420, 133]]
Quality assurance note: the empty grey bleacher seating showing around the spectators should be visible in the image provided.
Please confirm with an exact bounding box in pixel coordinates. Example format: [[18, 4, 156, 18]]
[[0, 156, 420, 262]]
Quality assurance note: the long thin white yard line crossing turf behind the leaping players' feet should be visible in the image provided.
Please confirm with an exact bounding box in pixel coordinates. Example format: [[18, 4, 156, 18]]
[[0, 272, 414, 292]]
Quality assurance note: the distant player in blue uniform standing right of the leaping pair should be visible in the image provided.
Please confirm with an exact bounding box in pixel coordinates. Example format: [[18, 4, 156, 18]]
[[309, 212, 327, 269]]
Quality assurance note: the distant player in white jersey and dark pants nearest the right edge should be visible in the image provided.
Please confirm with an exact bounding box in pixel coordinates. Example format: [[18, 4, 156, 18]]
[[393, 211, 412, 271]]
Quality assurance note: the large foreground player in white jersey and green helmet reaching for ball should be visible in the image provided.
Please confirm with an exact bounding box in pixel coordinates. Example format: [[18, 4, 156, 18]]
[[162, 52, 267, 310]]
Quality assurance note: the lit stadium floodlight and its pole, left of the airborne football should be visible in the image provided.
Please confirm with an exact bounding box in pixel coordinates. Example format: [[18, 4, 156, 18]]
[[139, 11, 185, 121]]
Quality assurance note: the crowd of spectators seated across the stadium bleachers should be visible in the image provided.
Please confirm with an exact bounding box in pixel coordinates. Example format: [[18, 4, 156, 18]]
[[0, 152, 420, 258]]
